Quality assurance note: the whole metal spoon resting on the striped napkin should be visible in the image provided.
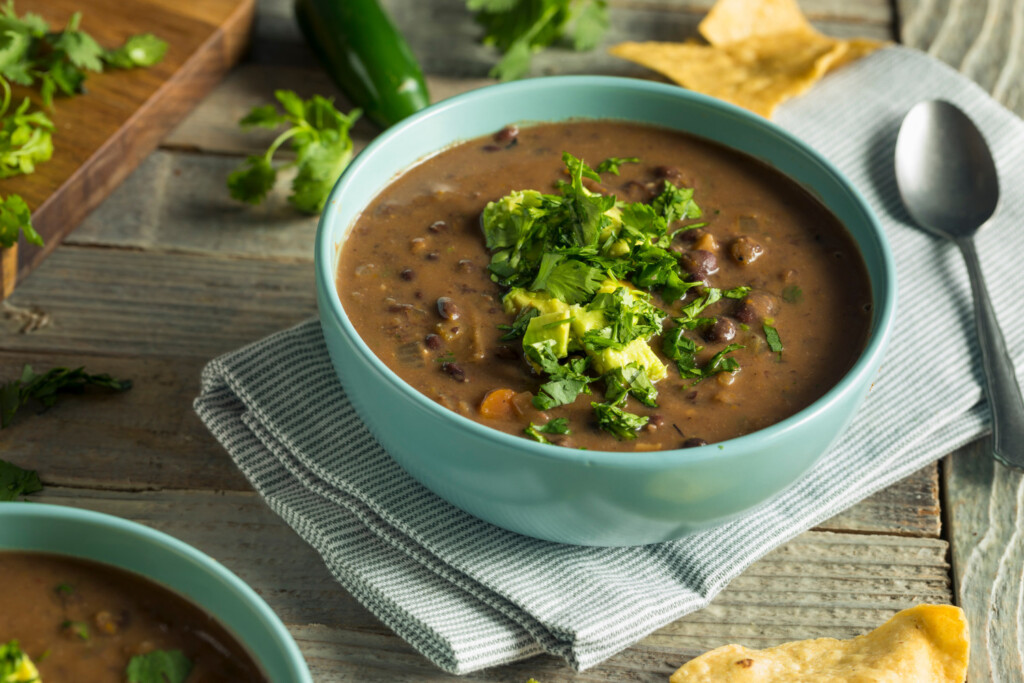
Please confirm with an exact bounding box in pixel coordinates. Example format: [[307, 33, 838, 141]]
[[896, 100, 1024, 469]]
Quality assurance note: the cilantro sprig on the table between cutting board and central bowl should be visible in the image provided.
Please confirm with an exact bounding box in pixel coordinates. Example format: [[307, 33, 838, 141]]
[[227, 90, 360, 214]]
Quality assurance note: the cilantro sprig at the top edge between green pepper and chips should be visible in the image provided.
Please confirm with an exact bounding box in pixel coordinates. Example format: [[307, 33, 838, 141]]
[[466, 0, 608, 81]]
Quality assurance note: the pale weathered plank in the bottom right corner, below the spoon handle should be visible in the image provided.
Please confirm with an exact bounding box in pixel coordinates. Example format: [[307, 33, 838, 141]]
[[943, 438, 1024, 683]]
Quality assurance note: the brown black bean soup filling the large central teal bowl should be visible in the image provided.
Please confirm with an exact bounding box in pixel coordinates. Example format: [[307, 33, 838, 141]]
[[337, 121, 871, 451]]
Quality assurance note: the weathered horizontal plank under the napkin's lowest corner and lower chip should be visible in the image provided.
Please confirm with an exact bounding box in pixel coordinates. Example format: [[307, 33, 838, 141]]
[[25, 488, 951, 683]]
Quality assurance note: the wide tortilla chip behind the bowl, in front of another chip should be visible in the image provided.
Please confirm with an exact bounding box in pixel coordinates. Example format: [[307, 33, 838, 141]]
[[610, 31, 846, 117]]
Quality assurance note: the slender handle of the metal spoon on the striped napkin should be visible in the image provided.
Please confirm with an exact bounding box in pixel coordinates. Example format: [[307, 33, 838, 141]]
[[956, 238, 1024, 469]]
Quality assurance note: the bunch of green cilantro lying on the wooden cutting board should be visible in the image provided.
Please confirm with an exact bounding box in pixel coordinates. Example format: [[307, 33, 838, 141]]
[[0, 0, 167, 248]]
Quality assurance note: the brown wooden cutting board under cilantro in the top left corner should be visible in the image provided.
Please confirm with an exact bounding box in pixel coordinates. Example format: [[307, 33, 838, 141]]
[[0, 0, 255, 299]]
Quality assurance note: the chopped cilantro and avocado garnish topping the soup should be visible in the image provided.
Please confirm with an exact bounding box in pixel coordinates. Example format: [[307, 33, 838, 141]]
[[481, 154, 770, 438]]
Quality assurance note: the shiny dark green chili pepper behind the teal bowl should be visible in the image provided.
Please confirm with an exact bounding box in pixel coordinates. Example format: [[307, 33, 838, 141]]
[[295, 0, 430, 128]]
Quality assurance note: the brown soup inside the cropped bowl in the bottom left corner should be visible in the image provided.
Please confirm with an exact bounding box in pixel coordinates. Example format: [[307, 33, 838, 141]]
[[0, 551, 266, 683]]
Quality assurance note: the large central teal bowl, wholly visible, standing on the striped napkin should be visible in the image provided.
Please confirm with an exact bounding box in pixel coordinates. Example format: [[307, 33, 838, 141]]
[[315, 76, 896, 546]]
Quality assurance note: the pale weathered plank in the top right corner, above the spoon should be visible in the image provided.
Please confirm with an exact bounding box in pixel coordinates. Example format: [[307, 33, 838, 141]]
[[896, 0, 1024, 116]]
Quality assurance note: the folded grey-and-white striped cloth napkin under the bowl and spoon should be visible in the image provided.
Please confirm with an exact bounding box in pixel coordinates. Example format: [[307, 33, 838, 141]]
[[196, 47, 1024, 674]]
